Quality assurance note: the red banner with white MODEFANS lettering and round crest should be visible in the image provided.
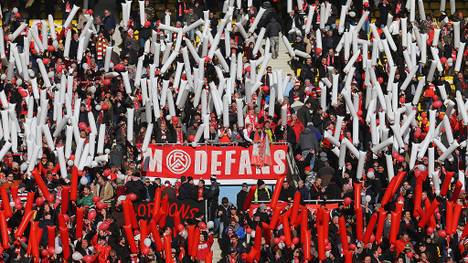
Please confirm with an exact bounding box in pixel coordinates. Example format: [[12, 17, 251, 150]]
[[143, 144, 288, 180]]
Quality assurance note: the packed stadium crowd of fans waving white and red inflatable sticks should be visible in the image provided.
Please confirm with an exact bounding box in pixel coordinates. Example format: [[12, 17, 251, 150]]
[[0, 0, 468, 263]]
